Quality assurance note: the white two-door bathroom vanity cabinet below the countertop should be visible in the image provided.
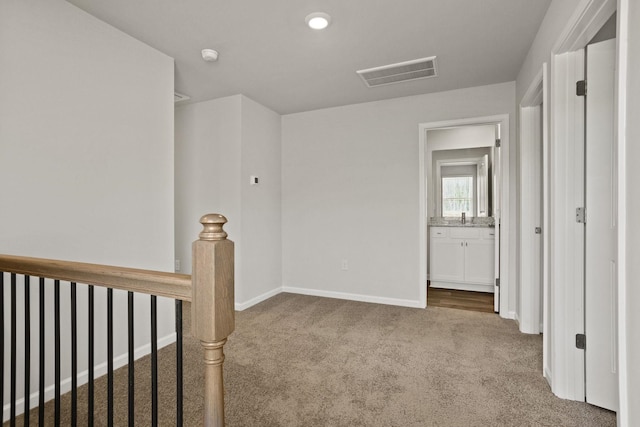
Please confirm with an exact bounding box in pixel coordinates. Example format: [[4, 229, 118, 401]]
[[429, 227, 495, 292]]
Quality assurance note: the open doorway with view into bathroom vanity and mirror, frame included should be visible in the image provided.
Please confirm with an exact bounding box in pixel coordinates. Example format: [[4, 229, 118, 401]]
[[420, 115, 511, 317]]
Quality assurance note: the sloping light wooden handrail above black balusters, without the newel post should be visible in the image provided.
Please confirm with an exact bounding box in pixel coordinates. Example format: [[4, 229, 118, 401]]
[[0, 255, 191, 301]]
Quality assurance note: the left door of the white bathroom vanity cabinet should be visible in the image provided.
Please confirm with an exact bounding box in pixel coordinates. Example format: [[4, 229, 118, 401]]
[[430, 238, 464, 282]]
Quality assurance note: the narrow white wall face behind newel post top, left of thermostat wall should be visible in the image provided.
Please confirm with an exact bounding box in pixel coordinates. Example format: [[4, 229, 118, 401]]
[[175, 95, 241, 274]]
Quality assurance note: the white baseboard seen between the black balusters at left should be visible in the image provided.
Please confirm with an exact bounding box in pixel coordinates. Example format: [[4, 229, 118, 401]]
[[2, 332, 176, 423]]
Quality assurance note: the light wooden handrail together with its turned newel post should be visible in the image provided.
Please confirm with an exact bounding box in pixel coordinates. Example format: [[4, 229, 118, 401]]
[[0, 214, 235, 427]]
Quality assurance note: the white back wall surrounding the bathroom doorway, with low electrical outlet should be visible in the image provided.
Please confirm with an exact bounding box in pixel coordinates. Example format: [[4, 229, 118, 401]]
[[282, 83, 515, 306]]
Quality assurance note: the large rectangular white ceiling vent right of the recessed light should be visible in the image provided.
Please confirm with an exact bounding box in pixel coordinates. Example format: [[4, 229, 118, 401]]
[[356, 56, 438, 87]]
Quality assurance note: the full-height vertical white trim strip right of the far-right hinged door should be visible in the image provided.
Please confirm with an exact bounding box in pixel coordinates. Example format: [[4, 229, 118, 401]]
[[614, 0, 631, 426]]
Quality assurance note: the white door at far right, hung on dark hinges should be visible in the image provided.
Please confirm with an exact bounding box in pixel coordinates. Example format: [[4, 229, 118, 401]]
[[585, 40, 618, 411]]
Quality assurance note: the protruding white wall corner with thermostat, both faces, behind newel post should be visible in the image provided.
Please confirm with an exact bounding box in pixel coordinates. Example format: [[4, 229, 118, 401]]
[[175, 95, 282, 310]]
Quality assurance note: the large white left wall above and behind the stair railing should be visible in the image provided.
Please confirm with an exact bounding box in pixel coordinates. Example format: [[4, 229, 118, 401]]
[[0, 0, 174, 420]]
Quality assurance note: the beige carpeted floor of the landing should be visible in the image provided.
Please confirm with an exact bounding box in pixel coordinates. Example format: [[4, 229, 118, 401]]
[[10, 294, 616, 427]]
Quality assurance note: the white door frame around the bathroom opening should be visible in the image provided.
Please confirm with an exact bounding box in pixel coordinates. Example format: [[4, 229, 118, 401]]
[[419, 114, 515, 318]]
